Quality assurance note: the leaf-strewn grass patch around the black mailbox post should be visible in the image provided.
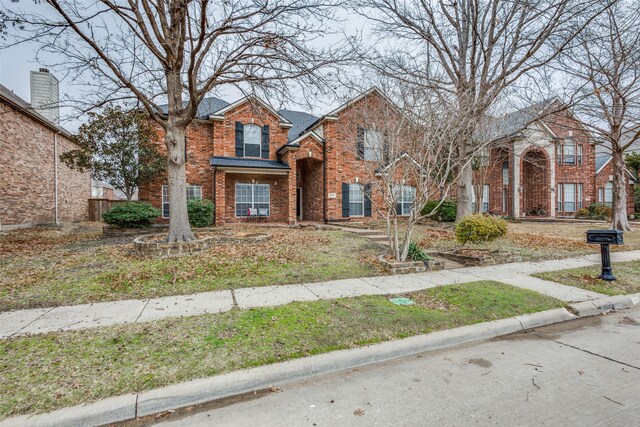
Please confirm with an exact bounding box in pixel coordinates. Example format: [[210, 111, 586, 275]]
[[534, 261, 640, 295]]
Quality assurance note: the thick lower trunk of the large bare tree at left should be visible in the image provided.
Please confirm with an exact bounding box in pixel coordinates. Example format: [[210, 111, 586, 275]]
[[165, 124, 195, 242]]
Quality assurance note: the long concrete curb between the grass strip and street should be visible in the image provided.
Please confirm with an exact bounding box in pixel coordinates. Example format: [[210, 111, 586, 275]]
[[0, 293, 640, 427]]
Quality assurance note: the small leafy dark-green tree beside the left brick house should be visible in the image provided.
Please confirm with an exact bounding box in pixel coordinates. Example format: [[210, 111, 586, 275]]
[[60, 106, 167, 201]]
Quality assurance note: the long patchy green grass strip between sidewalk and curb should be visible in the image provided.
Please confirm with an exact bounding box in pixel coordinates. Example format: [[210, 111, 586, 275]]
[[0, 281, 562, 418]]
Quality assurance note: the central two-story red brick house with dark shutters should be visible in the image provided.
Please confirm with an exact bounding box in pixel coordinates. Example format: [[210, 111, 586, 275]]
[[139, 88, 411, 225]]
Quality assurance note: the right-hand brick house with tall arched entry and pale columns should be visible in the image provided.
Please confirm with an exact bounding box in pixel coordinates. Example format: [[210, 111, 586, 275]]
[[474, 99, 633, 218]]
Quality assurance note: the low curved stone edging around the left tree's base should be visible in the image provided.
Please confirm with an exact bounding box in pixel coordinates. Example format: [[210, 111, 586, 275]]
[[133, 233, 273, 258]]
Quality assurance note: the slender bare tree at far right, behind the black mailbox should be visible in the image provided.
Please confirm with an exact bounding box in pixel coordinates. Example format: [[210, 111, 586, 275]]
[[559, 0, 640, 230]]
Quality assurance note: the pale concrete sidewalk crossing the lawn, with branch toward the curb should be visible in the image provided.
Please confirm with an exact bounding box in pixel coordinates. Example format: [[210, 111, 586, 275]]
[[0, 251, 640, 339]]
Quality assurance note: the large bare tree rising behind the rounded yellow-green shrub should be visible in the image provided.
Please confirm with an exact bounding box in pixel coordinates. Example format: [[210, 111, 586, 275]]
[[358, 0, 616, 220]]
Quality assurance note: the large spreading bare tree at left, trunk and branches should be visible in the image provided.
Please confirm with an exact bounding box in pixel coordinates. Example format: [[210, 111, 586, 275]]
[[3, 0, 343, 242]]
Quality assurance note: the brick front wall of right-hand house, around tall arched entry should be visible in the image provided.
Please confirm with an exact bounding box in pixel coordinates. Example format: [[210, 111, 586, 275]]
[[474, 108, 633, 217]]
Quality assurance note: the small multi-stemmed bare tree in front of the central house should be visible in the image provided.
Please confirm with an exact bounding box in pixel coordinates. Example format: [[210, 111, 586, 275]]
[[342, 82, 468, 261]]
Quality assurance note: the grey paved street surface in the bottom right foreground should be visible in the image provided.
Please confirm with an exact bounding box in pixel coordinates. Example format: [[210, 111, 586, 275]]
[[152, 308, 640, 427]]
